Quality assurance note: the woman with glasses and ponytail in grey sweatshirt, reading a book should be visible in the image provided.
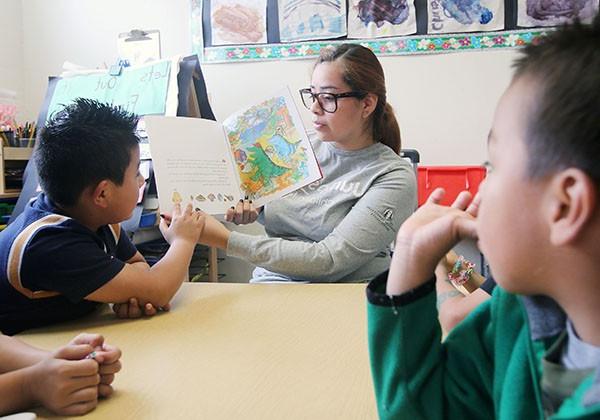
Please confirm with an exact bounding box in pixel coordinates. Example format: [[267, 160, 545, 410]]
[[192, 44, 417, 282]]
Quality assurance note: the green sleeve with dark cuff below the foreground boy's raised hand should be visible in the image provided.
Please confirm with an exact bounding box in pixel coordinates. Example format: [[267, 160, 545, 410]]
[[367, 273, 495, 420]]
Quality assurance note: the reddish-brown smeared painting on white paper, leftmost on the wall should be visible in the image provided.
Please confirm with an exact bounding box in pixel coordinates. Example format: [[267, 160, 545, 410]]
[[210, 0, 267, 45]]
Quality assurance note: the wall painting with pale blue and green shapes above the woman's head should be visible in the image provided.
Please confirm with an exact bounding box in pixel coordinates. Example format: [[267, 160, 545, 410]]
[[277, 0, 346, 42]]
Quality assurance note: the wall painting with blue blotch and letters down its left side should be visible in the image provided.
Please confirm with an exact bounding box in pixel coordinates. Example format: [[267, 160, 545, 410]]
[[427, 0, 504, 34]]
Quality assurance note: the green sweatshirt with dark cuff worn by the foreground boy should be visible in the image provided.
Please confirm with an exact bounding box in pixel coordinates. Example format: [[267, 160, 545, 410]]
[[367, 273, 600, 420]]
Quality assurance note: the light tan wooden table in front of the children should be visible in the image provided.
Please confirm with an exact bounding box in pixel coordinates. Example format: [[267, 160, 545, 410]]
[[19, 283, 377, 420]]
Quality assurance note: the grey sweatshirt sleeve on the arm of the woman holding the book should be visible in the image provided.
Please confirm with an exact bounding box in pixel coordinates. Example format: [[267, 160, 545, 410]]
[[227, 167, 416, 282]]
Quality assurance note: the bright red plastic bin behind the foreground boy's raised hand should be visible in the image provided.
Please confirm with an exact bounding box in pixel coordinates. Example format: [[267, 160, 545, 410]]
[[418, 166, 486, 206]]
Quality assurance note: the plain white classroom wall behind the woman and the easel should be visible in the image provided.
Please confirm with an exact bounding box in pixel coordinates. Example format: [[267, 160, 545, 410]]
[[16, 0, 516, 165]]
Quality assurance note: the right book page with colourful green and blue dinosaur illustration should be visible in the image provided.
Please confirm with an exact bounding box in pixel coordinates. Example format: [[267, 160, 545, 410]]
[[223, 89, 322, 207]]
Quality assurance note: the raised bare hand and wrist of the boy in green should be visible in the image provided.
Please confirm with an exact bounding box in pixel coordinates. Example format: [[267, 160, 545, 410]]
[[387, 188, 478, 295]]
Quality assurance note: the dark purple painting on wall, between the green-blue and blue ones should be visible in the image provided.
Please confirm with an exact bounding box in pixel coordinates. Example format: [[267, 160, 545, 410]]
[[348, 0, 417, 38]]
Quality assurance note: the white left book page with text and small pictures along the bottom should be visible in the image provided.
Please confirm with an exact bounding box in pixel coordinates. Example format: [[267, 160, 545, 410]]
[[144, 116, 242, 214]]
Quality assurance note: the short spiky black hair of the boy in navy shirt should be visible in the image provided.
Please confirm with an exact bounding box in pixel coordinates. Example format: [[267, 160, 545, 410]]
[[35, 98, 139, 206]]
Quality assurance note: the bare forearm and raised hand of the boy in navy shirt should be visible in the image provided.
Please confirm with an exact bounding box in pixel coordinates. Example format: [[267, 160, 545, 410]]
[[86, 204, 205, 308]]
